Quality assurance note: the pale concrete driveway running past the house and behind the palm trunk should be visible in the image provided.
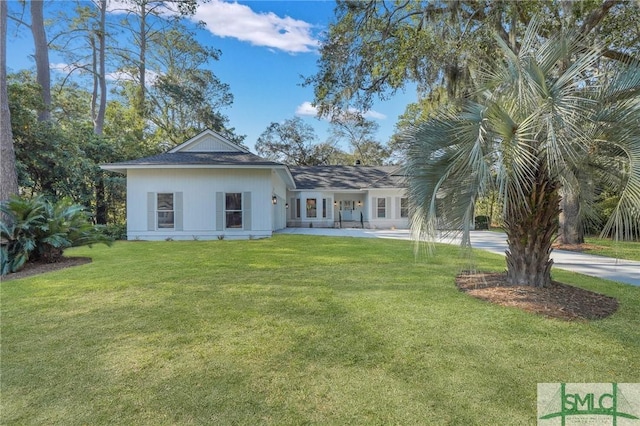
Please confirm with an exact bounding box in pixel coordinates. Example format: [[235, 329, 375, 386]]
[[276, 228, 640, 286]]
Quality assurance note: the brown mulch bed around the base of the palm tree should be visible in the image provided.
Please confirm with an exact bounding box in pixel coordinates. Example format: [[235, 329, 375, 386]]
[[456, 273, 618, 321]]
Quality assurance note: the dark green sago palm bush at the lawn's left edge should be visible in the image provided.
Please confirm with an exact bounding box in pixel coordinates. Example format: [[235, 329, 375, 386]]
[[0, 196, 113, 275]]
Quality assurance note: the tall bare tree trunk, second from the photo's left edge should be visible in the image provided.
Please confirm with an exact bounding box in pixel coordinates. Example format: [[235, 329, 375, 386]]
[[31, 0, 51, 121]]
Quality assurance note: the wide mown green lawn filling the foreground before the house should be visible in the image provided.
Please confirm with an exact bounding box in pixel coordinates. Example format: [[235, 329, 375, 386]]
[[0, 235, 640, 425]]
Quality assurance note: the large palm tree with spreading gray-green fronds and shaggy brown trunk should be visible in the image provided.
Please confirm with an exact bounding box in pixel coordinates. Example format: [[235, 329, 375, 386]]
[[404, 21, 640, 286]]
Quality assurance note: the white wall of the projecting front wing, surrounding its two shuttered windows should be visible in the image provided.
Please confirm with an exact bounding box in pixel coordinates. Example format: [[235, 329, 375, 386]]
[[127, 168, 286, 240]]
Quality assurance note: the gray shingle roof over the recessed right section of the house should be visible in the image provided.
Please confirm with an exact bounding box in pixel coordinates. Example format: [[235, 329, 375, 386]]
[[289, 166, 406, 189]]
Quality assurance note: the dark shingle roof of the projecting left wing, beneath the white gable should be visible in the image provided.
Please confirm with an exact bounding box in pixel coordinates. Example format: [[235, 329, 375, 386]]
[[104, 152, 282, 167]]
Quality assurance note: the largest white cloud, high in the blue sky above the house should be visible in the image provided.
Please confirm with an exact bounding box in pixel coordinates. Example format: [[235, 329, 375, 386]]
[[192, 0, 319, 53]]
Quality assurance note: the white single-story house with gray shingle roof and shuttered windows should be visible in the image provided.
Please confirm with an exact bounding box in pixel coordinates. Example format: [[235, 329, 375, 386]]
[[101, 130, 409, 240]]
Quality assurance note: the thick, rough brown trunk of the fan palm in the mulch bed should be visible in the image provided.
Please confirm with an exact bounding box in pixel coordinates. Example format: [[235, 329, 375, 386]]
[[505, 168, 560, 287]]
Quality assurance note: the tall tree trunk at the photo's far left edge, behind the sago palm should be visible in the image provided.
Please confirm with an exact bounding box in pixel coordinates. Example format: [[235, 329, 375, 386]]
[[0, 1, 18, 201]]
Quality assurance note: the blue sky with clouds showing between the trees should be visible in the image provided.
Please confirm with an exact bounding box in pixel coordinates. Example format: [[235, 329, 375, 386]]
[[7, 0, 416, 150]]
